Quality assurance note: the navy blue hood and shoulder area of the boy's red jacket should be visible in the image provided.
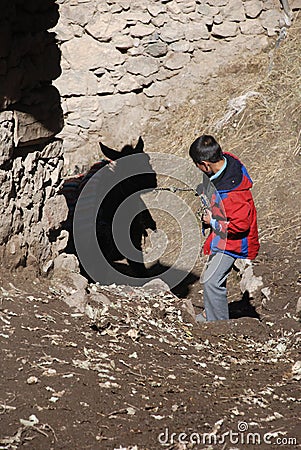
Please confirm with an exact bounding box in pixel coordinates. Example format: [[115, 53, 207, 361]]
[[212, 152, 253, 192]]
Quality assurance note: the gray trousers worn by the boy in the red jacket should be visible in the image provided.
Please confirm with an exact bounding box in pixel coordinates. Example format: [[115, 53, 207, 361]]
[[202, 253, 236, 321]]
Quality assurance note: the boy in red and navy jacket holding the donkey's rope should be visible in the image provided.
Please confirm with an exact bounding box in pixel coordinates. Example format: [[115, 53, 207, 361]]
[[189, 135, 259, 322]]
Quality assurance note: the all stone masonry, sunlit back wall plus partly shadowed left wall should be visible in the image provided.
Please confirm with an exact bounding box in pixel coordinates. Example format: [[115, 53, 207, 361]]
[[0, 0, 301, 274]]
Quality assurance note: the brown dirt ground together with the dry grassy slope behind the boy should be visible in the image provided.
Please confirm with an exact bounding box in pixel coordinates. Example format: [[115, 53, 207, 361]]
[[0, 19, 301, 450]]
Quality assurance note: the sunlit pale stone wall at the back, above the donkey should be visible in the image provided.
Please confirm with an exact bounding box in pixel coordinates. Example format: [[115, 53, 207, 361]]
[[55, 0, 301, 167]]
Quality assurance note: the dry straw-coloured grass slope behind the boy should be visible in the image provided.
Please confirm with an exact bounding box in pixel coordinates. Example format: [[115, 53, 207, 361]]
[[144, 15, 301, 264]]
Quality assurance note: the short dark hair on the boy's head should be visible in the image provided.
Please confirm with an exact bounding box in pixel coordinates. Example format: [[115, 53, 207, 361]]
[[189, 134, 223, 164]]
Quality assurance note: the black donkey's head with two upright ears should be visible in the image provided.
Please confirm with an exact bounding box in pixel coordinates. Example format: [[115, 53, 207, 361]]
[[100, 136, 157, 194]]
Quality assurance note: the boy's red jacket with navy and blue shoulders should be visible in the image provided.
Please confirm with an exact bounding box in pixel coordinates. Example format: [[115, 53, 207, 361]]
[[203, 153, 259, 259]]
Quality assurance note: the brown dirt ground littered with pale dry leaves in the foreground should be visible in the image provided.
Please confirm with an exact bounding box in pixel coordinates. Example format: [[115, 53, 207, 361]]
[[0, 255, 301, 450]]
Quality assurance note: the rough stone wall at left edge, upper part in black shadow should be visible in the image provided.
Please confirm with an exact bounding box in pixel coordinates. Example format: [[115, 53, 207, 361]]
[[0, 0, 67, 273]]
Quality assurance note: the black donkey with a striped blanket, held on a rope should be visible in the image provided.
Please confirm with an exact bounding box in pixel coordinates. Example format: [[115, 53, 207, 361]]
[[61, 137, 157, 282]]
